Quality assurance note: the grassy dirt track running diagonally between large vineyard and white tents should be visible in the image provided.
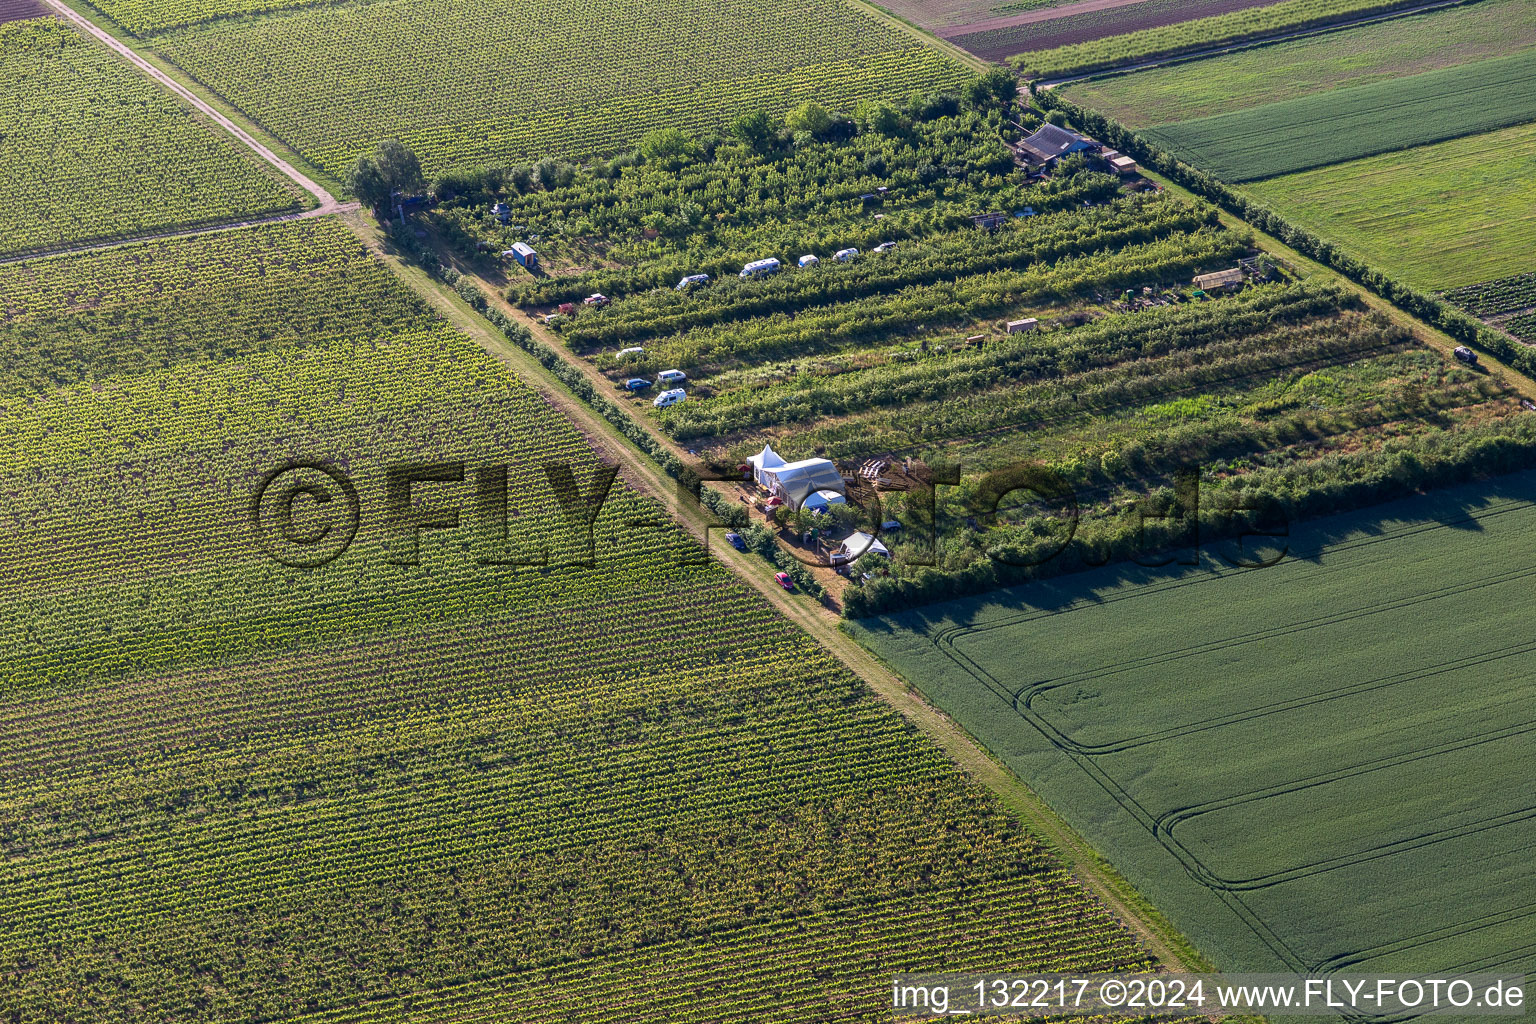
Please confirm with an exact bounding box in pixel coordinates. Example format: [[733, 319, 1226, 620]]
[[341, 213, 1212, 970]]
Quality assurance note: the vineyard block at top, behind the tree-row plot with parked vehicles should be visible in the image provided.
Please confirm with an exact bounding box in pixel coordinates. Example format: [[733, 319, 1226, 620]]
[[154, 0, 969, 175]]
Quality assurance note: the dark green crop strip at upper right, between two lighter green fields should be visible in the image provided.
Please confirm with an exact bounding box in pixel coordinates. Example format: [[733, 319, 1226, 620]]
[[1146, 48, 1536, 181]]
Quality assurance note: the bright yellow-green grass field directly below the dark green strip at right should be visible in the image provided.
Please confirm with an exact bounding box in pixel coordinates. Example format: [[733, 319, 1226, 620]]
[[1244, 124, 1536, 290]]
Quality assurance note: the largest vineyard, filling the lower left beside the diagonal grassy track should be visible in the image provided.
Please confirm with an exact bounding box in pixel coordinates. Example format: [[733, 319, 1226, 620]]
[[0, 220, 1147, 1024]]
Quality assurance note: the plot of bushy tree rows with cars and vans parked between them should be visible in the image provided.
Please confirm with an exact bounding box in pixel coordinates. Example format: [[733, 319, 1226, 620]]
[[448, 114, 1536, 608]]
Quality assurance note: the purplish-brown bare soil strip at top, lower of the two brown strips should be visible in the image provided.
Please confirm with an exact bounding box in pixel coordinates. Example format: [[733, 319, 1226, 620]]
[[943, 0, 1275, 61]]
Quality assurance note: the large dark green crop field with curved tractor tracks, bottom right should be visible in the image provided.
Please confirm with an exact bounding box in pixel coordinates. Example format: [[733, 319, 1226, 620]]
[[854, 474, 1536, 976]]
